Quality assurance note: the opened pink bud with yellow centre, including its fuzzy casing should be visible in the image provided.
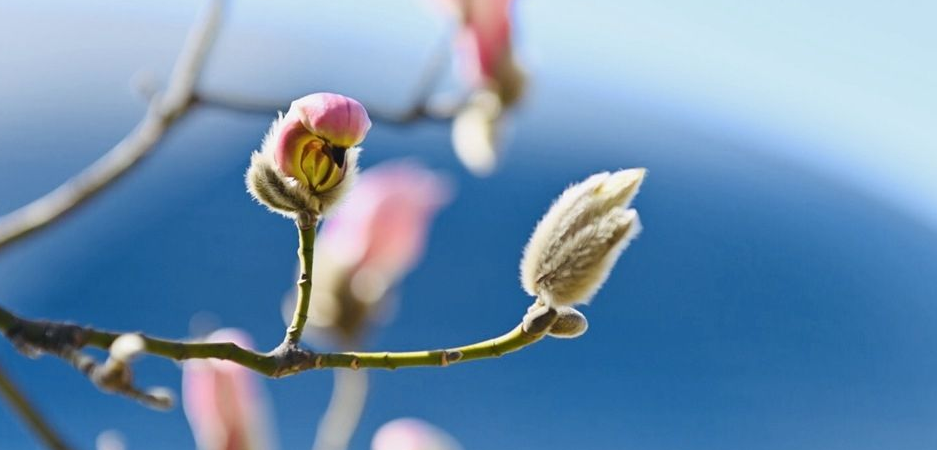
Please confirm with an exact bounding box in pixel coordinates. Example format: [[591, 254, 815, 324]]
[[247, 93, 371, 217]]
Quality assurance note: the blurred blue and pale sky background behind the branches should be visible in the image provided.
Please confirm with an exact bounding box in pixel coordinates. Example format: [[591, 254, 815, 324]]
[[0, 0, 937, 450]]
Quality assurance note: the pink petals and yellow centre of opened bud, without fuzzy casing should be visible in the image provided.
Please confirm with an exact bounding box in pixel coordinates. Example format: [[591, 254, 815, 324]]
[[272, 93, 371, 192]]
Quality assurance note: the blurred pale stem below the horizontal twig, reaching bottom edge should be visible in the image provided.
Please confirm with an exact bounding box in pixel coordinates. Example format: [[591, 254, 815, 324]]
[[312, 370, 368, 450]]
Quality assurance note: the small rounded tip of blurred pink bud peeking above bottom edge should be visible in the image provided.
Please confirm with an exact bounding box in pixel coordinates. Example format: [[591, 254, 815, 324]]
[[371, 418, 462, 450]]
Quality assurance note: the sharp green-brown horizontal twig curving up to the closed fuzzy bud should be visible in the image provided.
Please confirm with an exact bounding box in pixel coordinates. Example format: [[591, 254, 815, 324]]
[[0, 307, 557, 378]]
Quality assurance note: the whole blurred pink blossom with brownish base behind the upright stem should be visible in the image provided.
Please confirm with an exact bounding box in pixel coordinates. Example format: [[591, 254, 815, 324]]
[[285, 162, 451, 340]]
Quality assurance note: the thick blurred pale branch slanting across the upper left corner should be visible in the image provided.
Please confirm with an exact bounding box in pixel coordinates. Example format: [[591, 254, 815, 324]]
[[0, 0, 226, 248]]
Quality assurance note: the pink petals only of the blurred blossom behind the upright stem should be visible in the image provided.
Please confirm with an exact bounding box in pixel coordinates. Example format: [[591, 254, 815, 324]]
[[319, 161, 450, 282]]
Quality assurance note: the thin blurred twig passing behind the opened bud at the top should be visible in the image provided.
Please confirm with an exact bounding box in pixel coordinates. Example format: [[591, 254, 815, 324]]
[[191, 31, 464, 126]]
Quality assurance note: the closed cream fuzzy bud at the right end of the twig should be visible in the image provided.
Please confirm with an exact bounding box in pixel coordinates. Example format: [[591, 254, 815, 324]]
[[521, 169, 645, 307]]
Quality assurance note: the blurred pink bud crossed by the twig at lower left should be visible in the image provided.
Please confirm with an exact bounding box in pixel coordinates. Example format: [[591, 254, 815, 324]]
[[182, 329, 276, 450]]
